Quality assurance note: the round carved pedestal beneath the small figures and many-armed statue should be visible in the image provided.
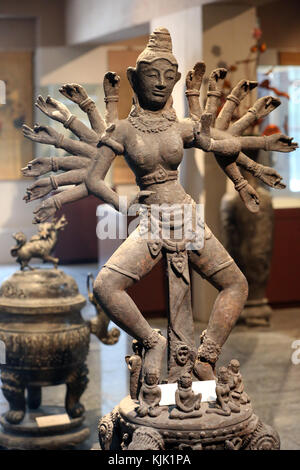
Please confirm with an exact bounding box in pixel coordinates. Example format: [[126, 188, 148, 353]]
[[99, 396, 280, 450]]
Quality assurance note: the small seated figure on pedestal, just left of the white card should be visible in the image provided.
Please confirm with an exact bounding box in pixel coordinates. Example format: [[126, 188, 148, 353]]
[[136, 370, 165, 418]]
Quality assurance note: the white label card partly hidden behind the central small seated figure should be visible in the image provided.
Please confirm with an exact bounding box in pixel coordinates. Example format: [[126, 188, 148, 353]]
[[159, 380, 217, 406]]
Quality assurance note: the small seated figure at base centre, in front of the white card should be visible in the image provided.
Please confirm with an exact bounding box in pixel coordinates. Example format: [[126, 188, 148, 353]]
[[170, 374, 202, 419]]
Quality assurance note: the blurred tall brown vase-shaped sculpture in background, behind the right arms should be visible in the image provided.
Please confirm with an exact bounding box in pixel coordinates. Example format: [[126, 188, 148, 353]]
[[221, 152, 274, 326]]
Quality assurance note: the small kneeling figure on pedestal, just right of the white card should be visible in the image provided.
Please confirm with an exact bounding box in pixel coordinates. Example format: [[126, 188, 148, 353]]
[[206, 367, 240, 416]]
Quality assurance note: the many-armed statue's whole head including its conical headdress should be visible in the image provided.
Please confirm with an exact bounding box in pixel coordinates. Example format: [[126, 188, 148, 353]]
[[127, 28, 181, 111]]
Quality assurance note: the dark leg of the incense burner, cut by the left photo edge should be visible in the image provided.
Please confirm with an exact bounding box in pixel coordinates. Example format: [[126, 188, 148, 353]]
[[1, 370, 26, 424]]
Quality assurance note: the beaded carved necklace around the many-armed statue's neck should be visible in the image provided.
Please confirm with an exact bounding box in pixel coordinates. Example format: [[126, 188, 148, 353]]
[[128, 106, 177, 133]]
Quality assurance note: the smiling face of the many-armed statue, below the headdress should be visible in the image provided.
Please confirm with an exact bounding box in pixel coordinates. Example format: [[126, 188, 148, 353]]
[[135, 59, 179, 111]]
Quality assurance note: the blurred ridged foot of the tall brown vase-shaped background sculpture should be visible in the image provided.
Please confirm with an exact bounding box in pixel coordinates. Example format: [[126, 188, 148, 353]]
[[239, 299, 272, 326]]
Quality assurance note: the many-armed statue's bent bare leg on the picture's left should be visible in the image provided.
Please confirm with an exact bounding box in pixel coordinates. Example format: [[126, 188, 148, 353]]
[[94, 228, 166, 373]]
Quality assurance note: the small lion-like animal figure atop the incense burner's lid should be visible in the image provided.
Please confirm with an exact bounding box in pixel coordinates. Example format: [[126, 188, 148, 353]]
[[10, 215, 68, 271]]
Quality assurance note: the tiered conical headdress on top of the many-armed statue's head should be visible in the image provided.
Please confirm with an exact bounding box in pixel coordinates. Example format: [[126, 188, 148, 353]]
[[136, 28, 178, 66]]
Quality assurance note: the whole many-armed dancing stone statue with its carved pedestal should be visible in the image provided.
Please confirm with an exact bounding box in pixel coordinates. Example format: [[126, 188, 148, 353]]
[[23, 28, 297, 449]]
